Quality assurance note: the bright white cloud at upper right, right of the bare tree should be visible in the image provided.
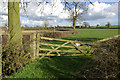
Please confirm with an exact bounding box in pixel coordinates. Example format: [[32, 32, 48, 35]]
[[84, 1, 118, 20]]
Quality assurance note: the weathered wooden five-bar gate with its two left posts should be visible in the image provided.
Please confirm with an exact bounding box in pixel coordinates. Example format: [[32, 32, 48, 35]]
[[31, 33, 94, 58]]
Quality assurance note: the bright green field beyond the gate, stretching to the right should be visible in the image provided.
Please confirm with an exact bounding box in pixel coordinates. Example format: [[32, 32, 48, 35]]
[[63, 29, 118, 42]]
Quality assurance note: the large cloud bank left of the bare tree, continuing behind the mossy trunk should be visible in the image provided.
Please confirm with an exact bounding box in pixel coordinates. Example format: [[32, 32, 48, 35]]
[[0, 0, 69, 25]]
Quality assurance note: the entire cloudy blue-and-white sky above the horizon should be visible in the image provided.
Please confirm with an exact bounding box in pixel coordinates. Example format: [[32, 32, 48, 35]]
[[0, 0, 120, 27]]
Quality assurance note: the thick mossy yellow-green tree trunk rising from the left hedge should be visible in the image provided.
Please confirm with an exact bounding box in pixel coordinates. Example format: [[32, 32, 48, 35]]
[[8, 0, 22, 46]]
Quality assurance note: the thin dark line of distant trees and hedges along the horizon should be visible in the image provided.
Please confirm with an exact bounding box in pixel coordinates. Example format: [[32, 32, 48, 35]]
[[1, 26, 120, 31]]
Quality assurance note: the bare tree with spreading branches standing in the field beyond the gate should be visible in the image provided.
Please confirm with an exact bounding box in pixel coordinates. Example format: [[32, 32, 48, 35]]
[[64, 0, 93, 31]]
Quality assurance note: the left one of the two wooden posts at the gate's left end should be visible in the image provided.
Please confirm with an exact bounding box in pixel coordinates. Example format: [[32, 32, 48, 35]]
[[30, 33, 36, 59]]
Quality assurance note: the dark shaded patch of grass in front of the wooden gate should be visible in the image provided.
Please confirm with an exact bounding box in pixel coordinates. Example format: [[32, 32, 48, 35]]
[[33, 56, 91, 78]]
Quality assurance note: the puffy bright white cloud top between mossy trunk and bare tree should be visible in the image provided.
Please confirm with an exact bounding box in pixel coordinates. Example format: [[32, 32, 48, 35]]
[[21, 0, 69, 20]]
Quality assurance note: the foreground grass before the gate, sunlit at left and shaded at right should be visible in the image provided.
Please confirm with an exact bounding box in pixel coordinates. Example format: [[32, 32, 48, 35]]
[[10, 56, 92, 78]]
